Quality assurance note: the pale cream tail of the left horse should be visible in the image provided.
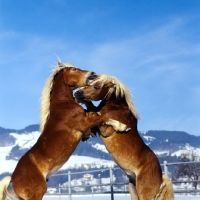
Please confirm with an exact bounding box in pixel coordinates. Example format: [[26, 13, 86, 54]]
[[0, 176, 18, 200]]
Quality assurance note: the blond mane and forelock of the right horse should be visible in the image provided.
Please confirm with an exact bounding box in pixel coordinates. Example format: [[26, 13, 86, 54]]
[[92, 74, 139, 119]]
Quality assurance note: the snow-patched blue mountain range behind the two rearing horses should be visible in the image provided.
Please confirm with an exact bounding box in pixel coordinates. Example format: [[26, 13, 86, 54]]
[[0, 124, 200, 177]]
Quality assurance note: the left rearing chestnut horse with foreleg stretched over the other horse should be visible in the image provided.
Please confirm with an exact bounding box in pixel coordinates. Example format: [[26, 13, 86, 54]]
[[0, 62, 129, 200]]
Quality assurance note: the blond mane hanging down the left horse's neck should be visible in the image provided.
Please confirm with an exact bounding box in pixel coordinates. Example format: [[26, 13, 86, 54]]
[[40, 63, 74, 132]]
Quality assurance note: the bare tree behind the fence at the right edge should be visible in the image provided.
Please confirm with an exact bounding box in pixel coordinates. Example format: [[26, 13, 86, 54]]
[[174, 147, 200, 189]]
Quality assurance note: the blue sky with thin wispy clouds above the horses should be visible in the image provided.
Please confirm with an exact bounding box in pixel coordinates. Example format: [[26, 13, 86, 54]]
[[0, 0, 200, 135]]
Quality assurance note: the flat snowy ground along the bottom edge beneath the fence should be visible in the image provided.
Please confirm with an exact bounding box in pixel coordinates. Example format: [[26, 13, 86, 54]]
[[43, 194, 200, 200]]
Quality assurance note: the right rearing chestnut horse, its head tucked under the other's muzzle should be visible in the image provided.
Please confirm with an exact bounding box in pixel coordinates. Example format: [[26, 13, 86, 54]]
[[74, 74, 174, 200]]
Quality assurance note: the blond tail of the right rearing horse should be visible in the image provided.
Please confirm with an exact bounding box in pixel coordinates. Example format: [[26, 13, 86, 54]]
[[154, 175, 174, 200]]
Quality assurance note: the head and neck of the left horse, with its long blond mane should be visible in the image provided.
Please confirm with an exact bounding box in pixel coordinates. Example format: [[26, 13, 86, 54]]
[[40, 62, 97, 131]]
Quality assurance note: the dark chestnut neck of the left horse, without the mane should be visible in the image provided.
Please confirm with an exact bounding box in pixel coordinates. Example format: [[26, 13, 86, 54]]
[[50, 73, 74, 104]]
